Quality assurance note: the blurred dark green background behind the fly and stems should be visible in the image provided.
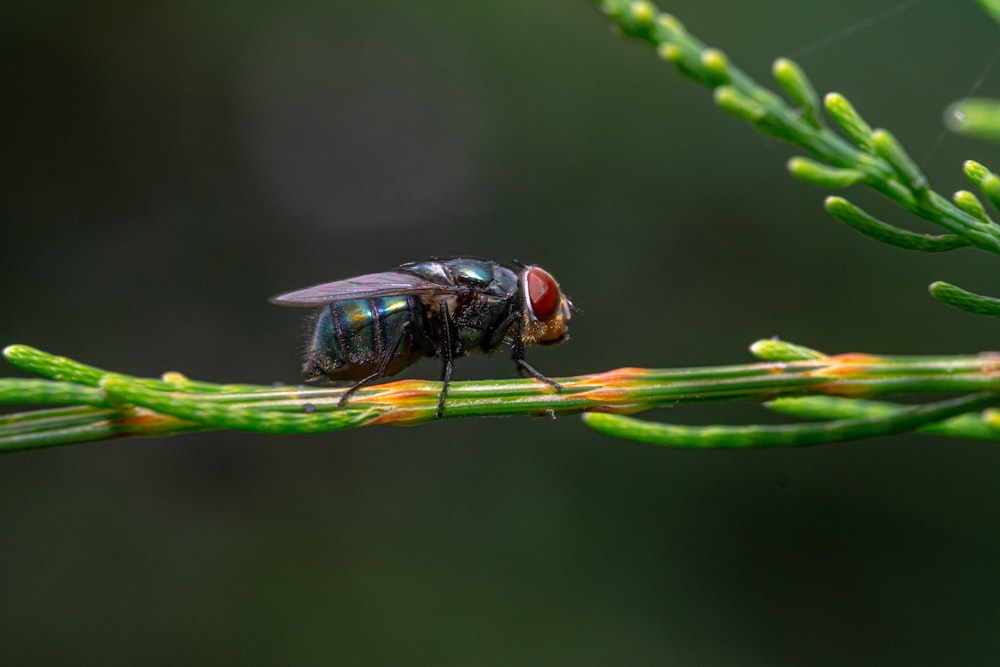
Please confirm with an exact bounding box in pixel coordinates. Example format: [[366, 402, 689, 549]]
[[0, 0, 1000, 665]]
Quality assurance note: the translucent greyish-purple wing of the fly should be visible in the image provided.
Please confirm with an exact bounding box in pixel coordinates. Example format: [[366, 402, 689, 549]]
[[270, 271, 461, 307]]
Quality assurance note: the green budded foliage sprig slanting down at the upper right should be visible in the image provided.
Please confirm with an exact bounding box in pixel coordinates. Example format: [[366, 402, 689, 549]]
[[597, 0, 1000, 315]]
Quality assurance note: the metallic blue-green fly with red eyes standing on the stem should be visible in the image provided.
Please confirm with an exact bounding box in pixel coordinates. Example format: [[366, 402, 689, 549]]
[[271, 258, 572, 417]]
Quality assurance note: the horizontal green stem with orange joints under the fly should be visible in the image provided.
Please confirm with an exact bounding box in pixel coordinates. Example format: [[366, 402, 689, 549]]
[[0, 340, 1000, 451]]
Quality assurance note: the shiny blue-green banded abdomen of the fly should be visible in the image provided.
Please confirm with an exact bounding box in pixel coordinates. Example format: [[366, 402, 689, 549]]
[[302, 296, 433, 380]]
